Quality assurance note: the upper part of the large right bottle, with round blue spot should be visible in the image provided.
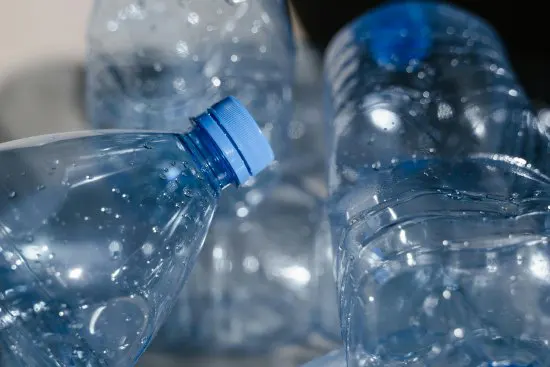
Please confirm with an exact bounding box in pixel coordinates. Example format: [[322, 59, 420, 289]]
[[325, 2, 548, 207]]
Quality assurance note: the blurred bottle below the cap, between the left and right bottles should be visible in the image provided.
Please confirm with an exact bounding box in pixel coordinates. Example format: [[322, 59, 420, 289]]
[[151, 45, 339, 354]]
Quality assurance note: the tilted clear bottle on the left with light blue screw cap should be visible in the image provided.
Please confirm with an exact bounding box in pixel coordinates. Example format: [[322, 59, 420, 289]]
[[0, 98, 273, 367]]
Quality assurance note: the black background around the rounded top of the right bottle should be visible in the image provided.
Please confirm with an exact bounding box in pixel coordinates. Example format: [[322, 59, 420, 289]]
[[291, 0, 550, 106]]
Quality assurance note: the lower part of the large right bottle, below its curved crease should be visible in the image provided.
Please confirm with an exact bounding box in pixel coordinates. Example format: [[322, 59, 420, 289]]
[[339, 157, 550, 366]]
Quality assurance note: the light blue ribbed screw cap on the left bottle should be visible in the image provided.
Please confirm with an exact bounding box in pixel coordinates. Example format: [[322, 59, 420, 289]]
[[194, 97, 274, 185]]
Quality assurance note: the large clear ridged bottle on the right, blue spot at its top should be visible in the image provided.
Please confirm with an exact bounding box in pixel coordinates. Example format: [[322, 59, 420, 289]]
[[325, 3, 550, 367]]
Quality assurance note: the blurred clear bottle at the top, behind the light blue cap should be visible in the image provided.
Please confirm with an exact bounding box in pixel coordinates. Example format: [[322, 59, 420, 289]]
[[86, 0, 293, 155]]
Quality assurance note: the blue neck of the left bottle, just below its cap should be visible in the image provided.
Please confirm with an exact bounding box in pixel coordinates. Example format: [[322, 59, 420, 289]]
[[180, 125, 238, 193]]
